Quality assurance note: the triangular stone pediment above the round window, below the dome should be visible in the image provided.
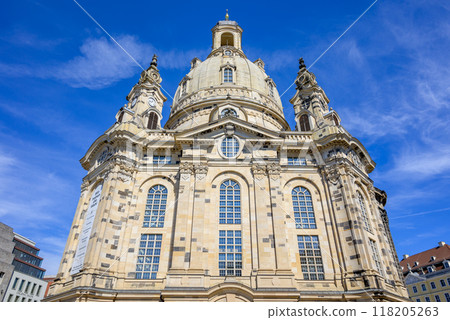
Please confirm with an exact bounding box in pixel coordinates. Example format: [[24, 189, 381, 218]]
[[175, 116, 282, 142]]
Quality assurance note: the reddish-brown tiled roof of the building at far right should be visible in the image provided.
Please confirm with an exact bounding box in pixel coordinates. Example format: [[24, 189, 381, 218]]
[[400, 243, 450, 273]]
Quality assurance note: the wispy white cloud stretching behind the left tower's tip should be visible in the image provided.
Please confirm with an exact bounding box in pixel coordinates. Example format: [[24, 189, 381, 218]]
[[0, 35, 207, 89]]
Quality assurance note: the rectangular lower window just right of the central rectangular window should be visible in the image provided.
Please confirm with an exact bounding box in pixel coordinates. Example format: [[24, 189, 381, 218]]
[[297, 236, 325, 280]]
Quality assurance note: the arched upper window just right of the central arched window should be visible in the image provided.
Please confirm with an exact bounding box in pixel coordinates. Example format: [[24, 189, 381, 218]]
[[292, 187, 317, 229]]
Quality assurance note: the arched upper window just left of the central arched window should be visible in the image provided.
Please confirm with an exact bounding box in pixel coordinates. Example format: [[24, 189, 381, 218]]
[[143, 185, 167, 228]]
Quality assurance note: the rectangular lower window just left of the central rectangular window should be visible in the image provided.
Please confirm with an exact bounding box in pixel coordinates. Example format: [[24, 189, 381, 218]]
[[135, 234, 162, 279]]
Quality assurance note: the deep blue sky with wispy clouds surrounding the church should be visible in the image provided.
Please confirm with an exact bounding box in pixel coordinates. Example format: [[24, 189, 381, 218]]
[[0, 0, 450, 274]]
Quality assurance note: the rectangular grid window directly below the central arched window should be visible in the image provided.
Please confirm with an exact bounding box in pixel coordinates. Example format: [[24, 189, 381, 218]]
[[219, 230, 242, 277]]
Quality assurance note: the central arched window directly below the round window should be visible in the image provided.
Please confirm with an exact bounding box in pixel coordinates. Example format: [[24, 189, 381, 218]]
[[219, 180, 241, 224]]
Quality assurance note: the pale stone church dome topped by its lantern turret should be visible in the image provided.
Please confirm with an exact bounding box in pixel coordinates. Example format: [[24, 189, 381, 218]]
[[166, 20, 289, 131]]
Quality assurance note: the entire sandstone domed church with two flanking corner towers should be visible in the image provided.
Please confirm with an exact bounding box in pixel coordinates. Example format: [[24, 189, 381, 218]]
[[46, 15, 407, 301]]
